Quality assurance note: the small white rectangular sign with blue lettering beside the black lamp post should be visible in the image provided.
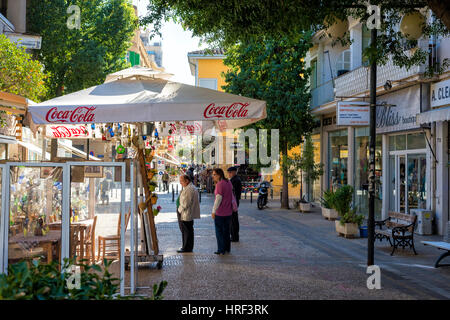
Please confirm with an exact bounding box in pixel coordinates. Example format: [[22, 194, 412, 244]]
[[337, 101, 370, 126]]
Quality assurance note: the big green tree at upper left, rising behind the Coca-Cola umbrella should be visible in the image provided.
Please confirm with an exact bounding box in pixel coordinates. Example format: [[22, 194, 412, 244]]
[[27, 0, 137, 98]]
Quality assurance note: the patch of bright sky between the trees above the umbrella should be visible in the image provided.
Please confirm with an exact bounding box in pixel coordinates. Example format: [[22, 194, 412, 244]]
[[133, 0, 206, 85]]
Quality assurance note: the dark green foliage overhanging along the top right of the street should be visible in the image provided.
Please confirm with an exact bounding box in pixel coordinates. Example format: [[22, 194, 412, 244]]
[[141, 0, 450, 67]]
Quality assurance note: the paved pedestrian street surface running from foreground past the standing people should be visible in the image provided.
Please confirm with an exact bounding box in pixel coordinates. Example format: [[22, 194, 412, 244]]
[[116, 188, 450, 300]]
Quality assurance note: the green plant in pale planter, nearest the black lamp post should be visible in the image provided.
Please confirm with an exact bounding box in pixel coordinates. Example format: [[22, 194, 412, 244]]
[[334, 185, 364, 238]]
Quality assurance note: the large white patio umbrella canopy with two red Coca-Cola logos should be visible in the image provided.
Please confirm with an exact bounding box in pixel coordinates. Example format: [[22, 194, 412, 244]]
[[29, 78, 266, 131]]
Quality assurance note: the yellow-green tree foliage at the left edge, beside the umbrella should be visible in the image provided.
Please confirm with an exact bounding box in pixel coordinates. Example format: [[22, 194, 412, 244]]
[[0, 34, 46, 102]]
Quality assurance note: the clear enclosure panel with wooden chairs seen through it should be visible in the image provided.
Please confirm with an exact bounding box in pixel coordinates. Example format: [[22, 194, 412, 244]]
[[70, 166, 131, 266]]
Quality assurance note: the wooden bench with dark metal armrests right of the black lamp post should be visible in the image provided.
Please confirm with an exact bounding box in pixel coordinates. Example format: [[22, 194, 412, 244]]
[[374, 212, 417, 256]]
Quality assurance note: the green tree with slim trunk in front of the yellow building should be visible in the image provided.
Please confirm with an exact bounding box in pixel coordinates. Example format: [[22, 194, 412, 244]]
[[222, 34, 314, 208]]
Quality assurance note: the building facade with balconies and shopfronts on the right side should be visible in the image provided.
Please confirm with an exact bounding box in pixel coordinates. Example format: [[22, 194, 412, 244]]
[[307, 18, 450, 234]]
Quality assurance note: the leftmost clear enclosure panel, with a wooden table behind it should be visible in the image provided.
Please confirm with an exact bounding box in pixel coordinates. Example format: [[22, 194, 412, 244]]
[[8, 167, 62, 263]]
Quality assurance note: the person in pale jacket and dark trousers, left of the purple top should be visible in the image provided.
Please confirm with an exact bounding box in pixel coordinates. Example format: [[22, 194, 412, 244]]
[[177, 175, 200, 253]]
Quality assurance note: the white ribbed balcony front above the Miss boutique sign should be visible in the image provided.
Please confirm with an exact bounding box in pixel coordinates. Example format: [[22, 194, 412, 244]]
[[335, 60, 425, 96]]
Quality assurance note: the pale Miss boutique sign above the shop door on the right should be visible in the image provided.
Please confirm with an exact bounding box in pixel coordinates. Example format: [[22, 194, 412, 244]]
[[377, 86, 420, 133]]
